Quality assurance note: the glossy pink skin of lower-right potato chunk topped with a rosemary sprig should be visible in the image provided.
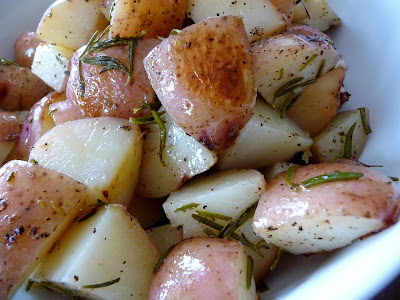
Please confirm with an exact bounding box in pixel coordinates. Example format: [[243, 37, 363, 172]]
[[253, 159, 400, 231]]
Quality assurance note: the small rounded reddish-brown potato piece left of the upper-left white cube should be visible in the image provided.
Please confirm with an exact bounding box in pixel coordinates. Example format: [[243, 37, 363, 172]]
[[14, 32, 42, 68]]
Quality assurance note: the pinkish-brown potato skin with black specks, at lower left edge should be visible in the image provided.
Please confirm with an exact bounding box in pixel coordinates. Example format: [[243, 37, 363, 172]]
[[0, 160, 86, 299]]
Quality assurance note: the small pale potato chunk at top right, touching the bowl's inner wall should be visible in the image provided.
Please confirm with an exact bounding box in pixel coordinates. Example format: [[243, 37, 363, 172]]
[[293, 0, 341, 31]]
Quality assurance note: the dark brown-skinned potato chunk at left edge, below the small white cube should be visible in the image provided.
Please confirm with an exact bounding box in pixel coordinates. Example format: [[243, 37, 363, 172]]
[[0, 65, 50, 111]]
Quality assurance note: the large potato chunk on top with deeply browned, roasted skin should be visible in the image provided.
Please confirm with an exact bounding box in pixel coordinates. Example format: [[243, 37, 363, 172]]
[[144, 16, 256, 152]]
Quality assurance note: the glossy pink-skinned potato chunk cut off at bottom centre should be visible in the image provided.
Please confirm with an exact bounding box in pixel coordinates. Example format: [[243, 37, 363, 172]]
[[149, 238, 257, 300]]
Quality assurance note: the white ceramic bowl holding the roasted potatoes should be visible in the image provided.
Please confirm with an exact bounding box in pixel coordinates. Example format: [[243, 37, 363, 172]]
[[0, 0, 400, 300]]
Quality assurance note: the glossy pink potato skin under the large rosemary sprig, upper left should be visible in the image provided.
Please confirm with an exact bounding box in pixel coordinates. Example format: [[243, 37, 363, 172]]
[[67, 39, 160, 119]]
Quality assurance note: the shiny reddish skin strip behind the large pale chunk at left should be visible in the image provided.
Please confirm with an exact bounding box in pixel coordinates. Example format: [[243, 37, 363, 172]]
[[7, 92, 65, 160]]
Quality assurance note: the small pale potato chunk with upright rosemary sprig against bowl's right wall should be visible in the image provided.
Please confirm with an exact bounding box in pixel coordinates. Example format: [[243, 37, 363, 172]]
[[311, 108, 369, 162]]
